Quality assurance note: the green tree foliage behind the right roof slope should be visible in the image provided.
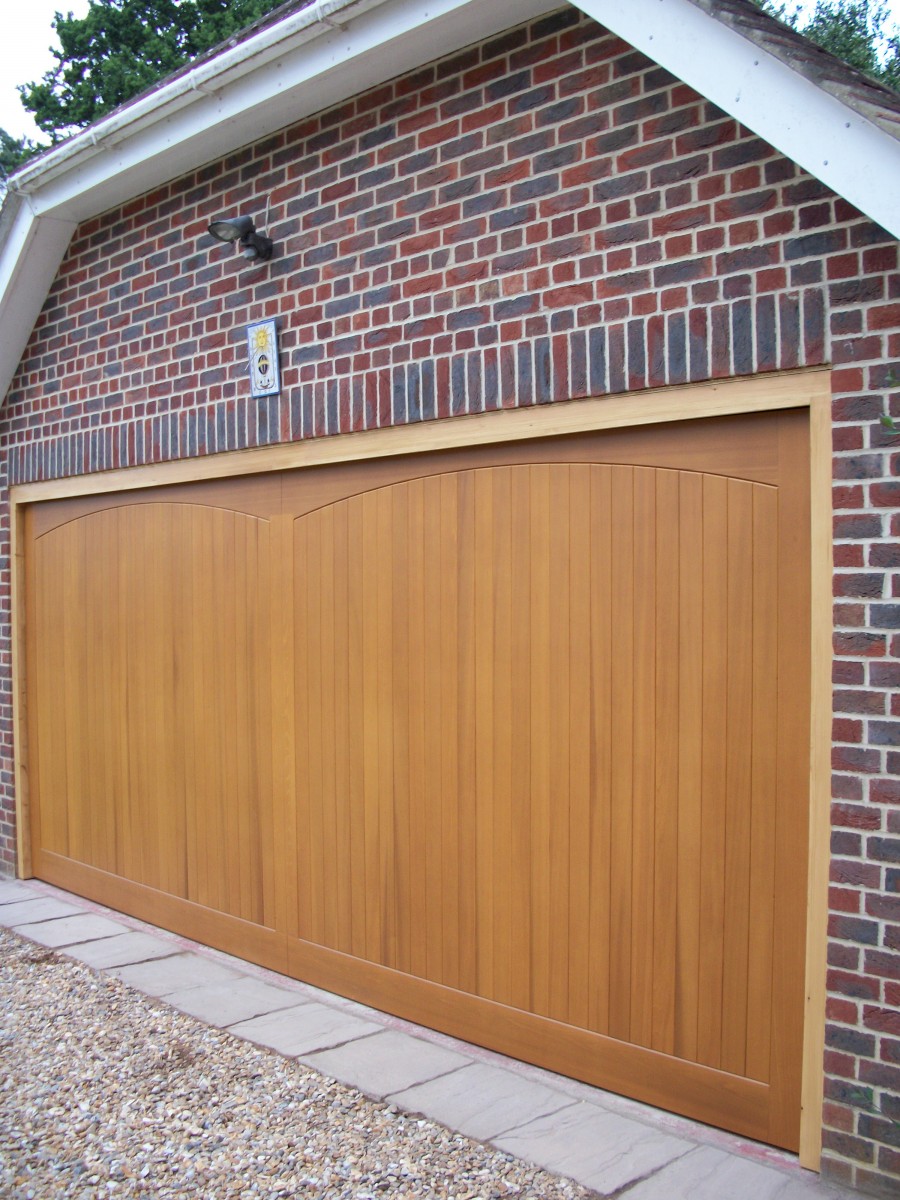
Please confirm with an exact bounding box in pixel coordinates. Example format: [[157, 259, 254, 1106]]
[[756, 0, 900, 91]]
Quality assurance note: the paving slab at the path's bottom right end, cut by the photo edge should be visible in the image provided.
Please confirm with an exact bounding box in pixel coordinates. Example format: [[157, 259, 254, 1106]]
[[628, 1146, 847, 1200]]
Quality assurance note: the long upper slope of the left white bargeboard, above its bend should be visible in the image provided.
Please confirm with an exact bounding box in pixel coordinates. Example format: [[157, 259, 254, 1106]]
[[23, 0, 559, 220]]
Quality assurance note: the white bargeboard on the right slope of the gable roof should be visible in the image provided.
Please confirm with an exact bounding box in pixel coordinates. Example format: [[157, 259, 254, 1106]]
[[572, 0, 900, 236]]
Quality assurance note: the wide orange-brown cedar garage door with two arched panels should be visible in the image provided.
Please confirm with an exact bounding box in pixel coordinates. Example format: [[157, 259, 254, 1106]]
[[25, 412, 809, 1147]]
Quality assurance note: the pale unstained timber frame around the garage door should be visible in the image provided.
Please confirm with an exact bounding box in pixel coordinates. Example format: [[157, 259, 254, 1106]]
[[10, 367, 833, 1170]]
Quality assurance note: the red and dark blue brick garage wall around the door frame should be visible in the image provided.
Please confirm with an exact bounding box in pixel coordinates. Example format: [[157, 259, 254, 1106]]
[[0, 10, 900, 1195]]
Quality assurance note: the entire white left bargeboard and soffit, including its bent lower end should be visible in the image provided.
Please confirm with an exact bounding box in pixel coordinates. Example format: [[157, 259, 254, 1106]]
[[0, 0, 560, 397]]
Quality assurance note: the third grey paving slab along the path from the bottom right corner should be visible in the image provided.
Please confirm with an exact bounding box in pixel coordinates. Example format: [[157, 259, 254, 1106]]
[[389, 1062, 577, 1141]]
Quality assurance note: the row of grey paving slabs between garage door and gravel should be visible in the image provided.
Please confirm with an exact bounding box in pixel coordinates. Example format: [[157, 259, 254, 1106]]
[[0, 881, 858, 1200]]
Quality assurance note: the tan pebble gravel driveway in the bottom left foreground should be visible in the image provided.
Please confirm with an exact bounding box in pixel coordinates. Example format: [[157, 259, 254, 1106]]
[[0, 931, 594, 1200]]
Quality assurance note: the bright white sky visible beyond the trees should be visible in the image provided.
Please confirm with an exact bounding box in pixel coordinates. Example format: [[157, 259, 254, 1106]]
[[0, 0, 900, 139]]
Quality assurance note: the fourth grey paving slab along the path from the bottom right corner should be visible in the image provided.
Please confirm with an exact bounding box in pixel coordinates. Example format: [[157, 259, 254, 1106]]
[[299, 1030, 470, 1099]]
